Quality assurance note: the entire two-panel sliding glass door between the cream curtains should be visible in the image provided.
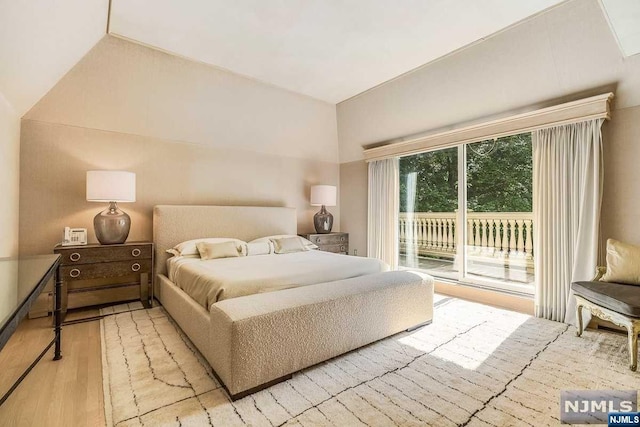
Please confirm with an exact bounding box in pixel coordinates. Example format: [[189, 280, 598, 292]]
[[399, 134, 534, 293]]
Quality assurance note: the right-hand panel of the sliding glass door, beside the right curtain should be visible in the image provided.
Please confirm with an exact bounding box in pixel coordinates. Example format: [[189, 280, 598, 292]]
[[465, 133, 533, 290]]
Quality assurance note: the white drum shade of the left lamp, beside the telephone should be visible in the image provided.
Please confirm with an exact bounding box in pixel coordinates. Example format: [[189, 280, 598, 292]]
[[87, 171, 136, 202]]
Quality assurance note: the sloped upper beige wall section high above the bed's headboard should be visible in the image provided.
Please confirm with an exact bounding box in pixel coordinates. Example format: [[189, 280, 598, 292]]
[[24, 36, 338, 163]]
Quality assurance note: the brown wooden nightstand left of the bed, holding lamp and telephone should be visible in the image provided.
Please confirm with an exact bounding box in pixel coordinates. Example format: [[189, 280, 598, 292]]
[[53, 242, 153, 313]]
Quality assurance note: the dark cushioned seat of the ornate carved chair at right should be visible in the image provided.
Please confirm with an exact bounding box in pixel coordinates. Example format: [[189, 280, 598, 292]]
[[571, 282, 640, 317]]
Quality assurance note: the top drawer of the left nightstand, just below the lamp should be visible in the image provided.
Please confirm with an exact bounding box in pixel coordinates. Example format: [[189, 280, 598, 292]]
[[55, 245, 152, 266]]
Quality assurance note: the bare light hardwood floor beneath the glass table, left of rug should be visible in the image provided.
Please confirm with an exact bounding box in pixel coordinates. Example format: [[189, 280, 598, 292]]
[[0, 317, 105, 426]]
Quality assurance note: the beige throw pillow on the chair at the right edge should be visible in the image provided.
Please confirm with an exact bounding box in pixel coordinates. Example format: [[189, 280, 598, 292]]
[[602, 239, 640, 285]]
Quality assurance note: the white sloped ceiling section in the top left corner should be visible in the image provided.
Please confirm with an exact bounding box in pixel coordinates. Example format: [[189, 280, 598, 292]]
[[0, 0, 109, 116]]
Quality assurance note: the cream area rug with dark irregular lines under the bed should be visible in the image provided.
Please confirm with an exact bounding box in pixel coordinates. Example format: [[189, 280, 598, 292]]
[[101, 298, 640, 426]]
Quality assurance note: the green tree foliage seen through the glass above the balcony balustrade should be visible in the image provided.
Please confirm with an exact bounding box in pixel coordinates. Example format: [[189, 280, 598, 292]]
[[400, 133, 533, 212]]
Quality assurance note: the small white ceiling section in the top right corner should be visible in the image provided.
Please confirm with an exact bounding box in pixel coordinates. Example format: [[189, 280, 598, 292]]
[[602, 0, 640, 56]]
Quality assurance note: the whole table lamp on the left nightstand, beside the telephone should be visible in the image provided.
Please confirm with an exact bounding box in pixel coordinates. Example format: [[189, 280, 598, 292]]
[[87, 171, 136, 245]]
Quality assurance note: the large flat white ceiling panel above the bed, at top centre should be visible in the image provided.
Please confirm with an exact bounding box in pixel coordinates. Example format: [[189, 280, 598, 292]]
[[109, 0, 564, 103]]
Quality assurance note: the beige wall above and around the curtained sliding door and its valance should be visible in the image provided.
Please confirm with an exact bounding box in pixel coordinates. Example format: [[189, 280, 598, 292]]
[[337, 0, 640, 254]]
